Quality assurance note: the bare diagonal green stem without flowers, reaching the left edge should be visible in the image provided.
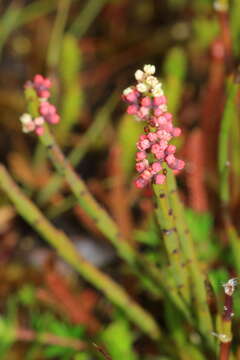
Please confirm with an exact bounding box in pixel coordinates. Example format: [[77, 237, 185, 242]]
[[0, 165, 161, 339]]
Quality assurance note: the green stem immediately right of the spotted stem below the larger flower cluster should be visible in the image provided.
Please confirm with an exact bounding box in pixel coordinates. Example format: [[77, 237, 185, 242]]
[[167, 170, 212, 337]]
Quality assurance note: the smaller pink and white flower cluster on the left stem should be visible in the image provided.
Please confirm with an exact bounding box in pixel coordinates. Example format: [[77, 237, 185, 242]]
[[20, 75, 60, 135]]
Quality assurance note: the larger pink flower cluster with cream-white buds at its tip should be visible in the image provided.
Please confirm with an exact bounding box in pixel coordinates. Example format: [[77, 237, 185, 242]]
[[122, 65, 185, 188]]
